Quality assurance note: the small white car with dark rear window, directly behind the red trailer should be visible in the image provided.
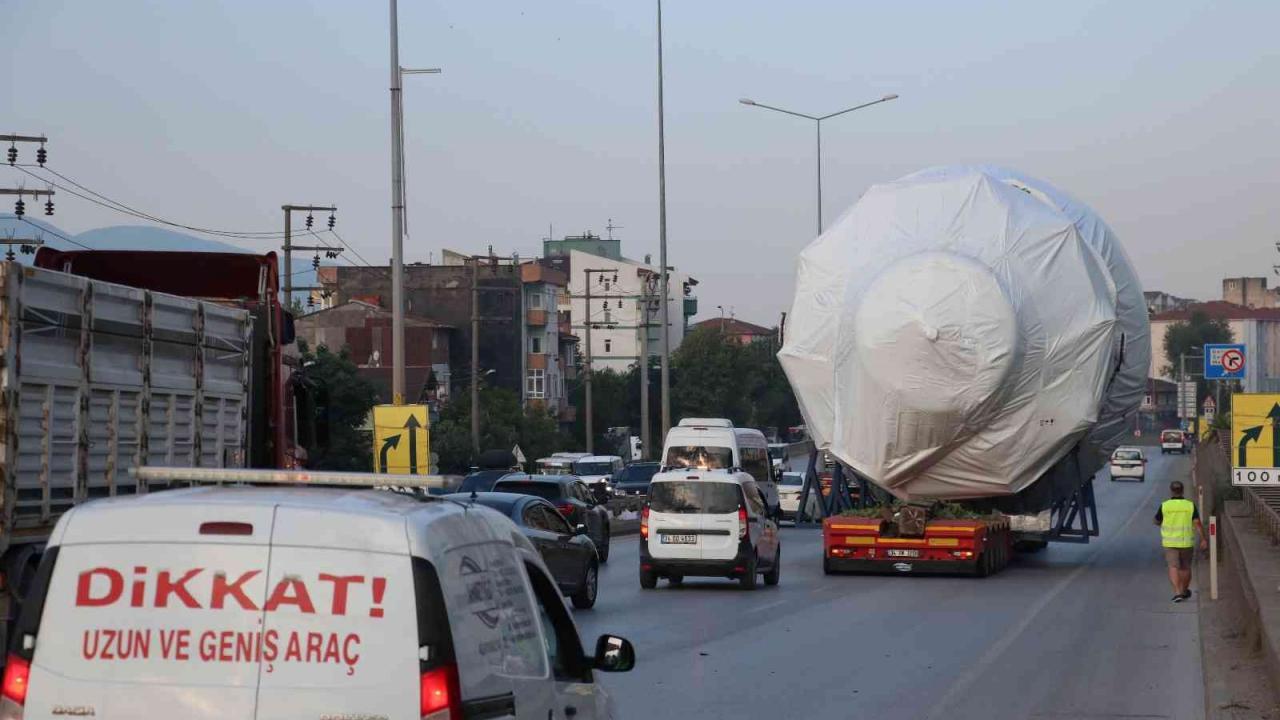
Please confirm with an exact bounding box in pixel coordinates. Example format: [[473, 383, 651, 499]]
[[640, 471, 782, 589]]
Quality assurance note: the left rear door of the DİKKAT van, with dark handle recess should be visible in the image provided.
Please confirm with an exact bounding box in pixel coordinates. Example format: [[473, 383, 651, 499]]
[[18, 502, 273, 720]]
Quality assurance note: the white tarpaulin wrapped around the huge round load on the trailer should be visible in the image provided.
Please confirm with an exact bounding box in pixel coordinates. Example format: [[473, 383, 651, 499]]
[[778, 167, 1151, 500]]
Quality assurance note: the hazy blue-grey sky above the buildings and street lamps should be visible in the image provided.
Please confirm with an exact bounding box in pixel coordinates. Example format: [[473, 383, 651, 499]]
[[0, 0, 1280, 324]]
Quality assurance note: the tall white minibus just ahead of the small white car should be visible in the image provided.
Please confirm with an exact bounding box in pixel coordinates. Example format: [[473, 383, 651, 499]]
[[662, 418, 782, 518]]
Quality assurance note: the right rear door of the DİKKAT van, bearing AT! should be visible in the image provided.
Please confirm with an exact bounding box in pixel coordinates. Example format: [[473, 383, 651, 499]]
[[257, 506, 419, 720]]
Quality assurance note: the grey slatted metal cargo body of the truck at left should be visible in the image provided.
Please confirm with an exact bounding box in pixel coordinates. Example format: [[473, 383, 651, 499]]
[[0, 261, 252, 641]]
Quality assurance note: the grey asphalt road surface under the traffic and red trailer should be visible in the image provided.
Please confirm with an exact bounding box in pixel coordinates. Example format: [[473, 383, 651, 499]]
[[576, 450, 1204, 720]]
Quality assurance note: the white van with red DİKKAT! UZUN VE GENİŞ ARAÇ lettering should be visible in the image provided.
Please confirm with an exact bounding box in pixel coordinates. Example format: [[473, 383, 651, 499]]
[[0, 468, 635, 720]]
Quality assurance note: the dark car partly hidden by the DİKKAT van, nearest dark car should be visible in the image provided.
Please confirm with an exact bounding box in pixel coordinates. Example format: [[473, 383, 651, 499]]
[[448, 492, 600, 610]]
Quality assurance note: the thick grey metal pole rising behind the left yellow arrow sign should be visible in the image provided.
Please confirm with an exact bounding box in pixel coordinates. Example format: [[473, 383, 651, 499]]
[[390, 0, 407, 404]]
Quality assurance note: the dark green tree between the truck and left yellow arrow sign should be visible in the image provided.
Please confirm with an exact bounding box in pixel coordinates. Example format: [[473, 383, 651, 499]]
[[298, 342, 378, 470]]
